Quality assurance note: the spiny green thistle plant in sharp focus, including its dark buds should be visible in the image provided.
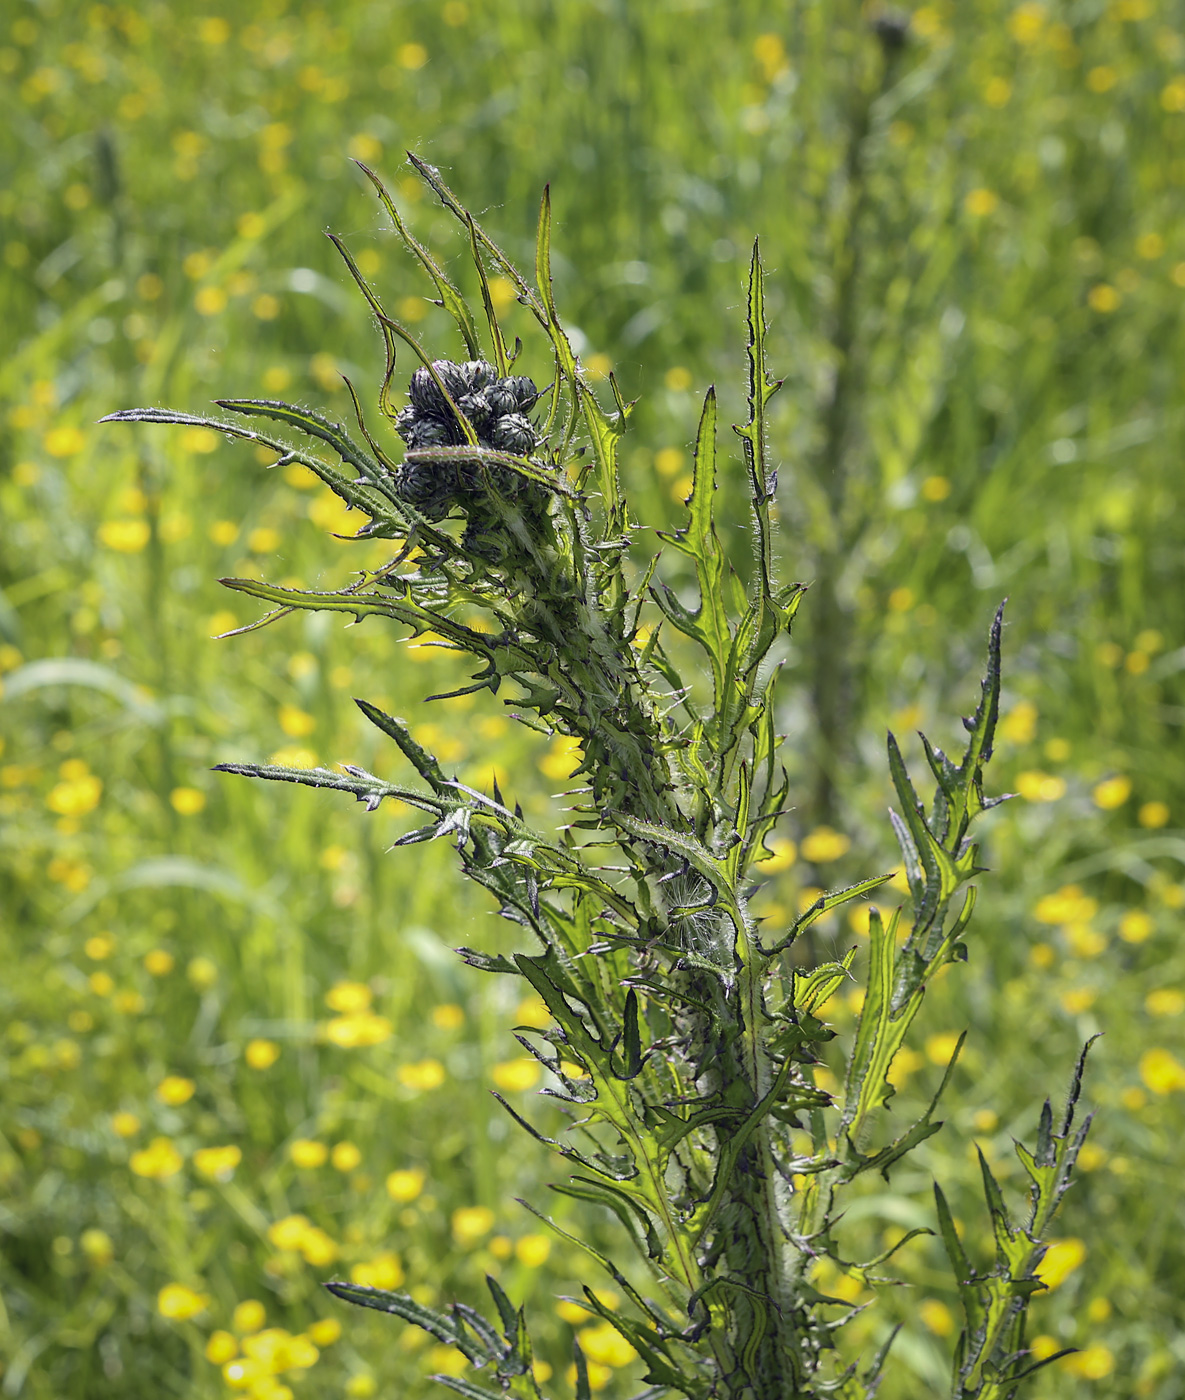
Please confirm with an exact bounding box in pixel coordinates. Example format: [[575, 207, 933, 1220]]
[[108, 157, 1090, 1400]]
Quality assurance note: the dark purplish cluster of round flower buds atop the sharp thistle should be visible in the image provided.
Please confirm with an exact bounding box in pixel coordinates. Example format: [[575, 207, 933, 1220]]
[[395, 360, 539, 519]]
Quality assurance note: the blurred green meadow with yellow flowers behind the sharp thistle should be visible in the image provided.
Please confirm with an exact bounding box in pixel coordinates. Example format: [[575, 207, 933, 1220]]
[[0, 0, 1185, 1400]]
